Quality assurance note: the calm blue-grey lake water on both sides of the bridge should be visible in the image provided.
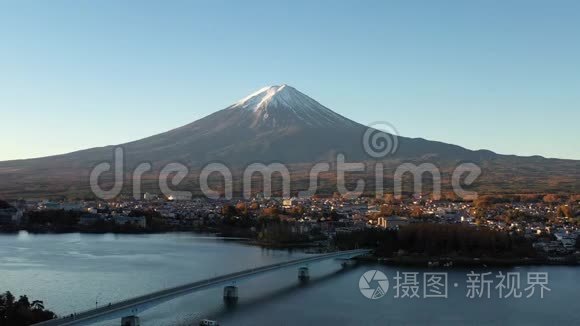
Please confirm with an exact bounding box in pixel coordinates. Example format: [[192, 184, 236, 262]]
[[0, 232, 580, 325]]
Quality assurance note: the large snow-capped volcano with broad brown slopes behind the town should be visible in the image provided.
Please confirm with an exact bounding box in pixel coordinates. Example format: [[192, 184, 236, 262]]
[[0, 85, 580, 198]]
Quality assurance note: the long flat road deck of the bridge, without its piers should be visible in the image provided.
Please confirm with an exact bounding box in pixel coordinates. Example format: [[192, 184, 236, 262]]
[[36, 249, 370, 326]]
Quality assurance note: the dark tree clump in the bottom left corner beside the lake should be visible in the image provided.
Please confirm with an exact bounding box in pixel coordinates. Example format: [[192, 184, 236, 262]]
[[0, 292, 56, 326]]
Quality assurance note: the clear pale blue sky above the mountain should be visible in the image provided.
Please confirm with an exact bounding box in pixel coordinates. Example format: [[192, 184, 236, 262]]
[[0, 0, 580, 160]]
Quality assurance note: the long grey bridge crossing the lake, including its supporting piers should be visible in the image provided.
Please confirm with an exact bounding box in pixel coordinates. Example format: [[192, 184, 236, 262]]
[[35, 249, 370, 326]]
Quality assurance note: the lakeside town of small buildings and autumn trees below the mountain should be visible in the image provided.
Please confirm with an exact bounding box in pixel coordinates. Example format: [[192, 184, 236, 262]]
[[0, 193, 580, 262]]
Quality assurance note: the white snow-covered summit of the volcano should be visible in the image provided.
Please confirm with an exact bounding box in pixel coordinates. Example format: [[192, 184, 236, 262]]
[[228, 84, 354, 127]]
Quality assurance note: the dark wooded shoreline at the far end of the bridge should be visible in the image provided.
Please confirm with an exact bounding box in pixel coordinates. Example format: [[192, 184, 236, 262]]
[[335, 224, 534, 257]]
